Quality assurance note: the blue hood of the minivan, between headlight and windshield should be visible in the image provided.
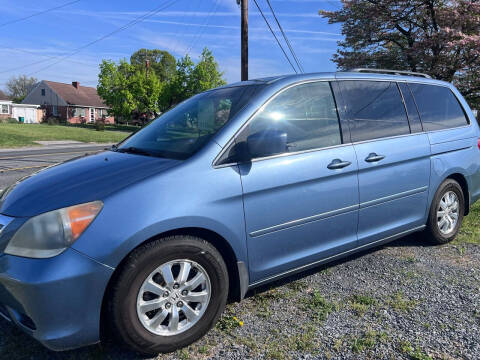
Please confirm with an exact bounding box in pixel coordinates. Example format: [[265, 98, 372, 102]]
[[0, 152, 180, 217]]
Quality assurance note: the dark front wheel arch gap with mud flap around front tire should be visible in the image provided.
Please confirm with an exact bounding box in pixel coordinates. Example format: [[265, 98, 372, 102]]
[[100, 227, 249, 336]]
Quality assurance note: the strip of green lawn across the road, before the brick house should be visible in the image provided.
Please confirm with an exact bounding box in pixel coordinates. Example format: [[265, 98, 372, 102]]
[[0, 124, 129, 148]]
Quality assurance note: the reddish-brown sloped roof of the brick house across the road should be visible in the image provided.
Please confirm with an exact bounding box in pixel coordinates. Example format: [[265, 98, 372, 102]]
[[44, 80, 107, 107]]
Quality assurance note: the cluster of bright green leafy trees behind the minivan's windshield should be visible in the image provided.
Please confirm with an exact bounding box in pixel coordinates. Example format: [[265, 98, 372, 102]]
[[97, 49, 225, 118]]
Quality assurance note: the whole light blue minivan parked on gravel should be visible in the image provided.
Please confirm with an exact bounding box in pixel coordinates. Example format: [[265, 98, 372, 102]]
[[0, 69, 480, 354]]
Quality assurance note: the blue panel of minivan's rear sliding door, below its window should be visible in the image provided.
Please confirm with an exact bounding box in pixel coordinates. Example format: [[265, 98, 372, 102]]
[[354, 133, 430, 244]]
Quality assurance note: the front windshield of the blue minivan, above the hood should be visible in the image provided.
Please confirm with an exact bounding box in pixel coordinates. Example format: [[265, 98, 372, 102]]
[[117, 85, 263, 160]]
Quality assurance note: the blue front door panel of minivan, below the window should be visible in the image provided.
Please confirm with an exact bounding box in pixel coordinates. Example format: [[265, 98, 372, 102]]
[[240, 145, 358, 282]]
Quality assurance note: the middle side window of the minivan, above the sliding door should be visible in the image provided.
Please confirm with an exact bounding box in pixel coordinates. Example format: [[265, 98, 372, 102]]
[[339, 80, 410, 142]]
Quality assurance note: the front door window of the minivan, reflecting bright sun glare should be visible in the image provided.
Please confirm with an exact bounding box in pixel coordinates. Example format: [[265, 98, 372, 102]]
[[239, 82, 342, 159]]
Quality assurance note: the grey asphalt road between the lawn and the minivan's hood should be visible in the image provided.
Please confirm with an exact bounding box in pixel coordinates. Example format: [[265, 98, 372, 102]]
[[0, 145, 106, 189]]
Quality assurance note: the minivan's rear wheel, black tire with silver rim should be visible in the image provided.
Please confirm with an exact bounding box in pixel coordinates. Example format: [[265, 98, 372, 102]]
[[426, 179, 465, 245]]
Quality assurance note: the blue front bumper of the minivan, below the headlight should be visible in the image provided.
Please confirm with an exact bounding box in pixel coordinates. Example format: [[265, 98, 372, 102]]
[[0, 249, 113, 351]]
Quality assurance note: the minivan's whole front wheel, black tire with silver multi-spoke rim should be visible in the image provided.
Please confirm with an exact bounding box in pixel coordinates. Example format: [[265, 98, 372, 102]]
[[109, 236, 229, 355]]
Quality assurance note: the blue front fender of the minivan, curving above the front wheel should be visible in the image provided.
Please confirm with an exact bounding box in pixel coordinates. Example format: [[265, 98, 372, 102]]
[[73, 160, 248, 268]]
